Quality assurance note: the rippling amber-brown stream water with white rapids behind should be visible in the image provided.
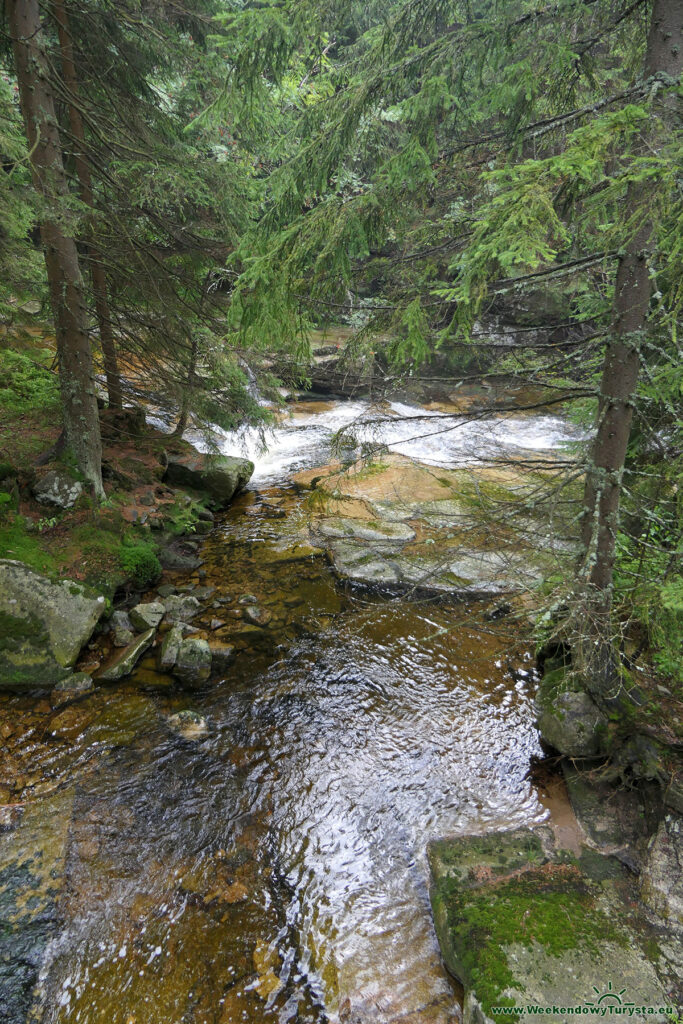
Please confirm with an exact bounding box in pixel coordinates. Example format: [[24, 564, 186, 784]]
[[0, 393, 581, 1024]]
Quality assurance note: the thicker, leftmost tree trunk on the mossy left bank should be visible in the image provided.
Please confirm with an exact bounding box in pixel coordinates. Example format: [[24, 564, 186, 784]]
[[5, 0, 104, 498]]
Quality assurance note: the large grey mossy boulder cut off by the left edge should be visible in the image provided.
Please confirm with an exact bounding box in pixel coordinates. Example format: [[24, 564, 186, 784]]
[[0, 559, 105, 690]]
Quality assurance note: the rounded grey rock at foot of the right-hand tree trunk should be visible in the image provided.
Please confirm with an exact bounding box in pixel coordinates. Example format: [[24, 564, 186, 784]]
[[536, 669, 607, 758]]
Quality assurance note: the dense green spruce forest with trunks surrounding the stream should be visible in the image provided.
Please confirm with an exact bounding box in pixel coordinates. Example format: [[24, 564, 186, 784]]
[[0, 0, 683, 761]]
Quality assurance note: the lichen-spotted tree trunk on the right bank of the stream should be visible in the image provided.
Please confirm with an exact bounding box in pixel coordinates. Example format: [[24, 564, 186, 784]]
[[578, 0, 683, 702]]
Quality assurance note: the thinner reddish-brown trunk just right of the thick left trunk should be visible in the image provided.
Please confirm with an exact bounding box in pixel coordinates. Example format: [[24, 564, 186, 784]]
[[52, 0, 123, 409]]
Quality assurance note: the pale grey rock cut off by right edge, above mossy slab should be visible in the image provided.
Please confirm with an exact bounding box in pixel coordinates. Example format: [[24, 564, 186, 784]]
[[640, 814, 683, 934]]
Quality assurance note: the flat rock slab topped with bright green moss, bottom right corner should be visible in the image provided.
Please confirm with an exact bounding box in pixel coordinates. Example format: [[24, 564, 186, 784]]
[[428, 828, 673, 1024]]
